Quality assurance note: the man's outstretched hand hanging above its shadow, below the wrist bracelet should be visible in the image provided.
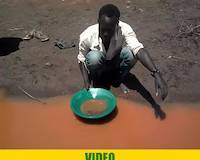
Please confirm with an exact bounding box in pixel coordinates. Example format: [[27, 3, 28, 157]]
[[154, 73, 168, 100]]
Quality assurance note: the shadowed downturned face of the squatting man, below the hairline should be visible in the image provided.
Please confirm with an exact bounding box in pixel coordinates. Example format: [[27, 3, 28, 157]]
[[99, 16, 117, 43]]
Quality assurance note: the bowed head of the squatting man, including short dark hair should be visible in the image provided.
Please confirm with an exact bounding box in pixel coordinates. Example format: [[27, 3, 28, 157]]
[[98, 4, 120, 43]]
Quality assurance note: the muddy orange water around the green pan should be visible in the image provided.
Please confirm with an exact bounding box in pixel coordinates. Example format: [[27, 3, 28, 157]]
[[0, 96, 200, 149]]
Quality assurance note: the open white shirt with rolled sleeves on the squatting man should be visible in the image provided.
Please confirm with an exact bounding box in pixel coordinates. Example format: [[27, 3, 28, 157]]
[[77, 21, 144, 63]]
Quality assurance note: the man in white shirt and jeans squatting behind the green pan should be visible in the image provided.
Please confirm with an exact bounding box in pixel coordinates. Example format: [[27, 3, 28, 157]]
[[77, 4, 168, 100]]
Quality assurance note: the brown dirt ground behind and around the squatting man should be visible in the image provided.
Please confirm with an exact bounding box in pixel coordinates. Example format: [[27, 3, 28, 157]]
[[0, 0, 200, 102]]
